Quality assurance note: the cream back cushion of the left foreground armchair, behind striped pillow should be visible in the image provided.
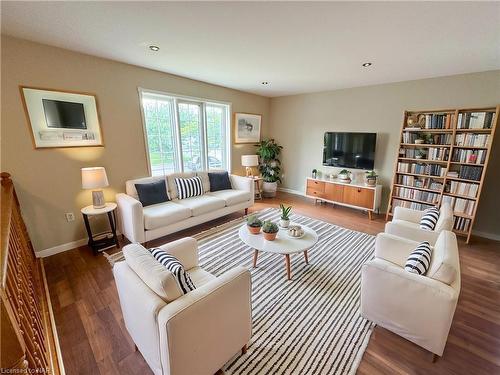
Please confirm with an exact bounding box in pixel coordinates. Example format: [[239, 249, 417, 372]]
[[123, 244, 183, 302]]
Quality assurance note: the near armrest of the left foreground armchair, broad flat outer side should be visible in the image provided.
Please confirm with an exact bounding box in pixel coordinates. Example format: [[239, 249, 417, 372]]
[[158, 267, 252, 374]]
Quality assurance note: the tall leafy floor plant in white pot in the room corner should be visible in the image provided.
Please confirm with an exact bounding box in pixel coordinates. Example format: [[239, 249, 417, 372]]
[[257, 139, 283, 197]]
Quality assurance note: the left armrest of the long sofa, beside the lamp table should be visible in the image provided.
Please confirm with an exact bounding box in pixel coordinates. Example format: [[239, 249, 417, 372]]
[[116, 193, 146, 243]]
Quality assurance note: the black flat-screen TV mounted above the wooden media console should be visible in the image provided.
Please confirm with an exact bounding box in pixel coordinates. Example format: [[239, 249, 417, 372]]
[[323, 132, 377, 169]]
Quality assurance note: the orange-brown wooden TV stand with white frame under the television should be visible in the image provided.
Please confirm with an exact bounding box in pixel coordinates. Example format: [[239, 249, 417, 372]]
[[306, 177, 382, 220]]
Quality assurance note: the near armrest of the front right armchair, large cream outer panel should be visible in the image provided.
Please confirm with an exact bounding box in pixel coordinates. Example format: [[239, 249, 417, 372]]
[[361, 259, 459, 355]]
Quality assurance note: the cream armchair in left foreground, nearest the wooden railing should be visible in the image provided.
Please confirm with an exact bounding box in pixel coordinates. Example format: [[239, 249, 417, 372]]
[[113, 238, 252, 375]]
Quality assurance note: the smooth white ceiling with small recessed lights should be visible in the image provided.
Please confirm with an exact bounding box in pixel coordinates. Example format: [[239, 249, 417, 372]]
[[1, 1, 500, 96]]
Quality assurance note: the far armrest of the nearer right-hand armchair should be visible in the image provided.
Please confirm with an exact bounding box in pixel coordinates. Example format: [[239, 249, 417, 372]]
[[375, 233, 418, 267]]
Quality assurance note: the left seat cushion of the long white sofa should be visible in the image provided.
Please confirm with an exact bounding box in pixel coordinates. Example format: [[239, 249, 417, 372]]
[[143, 201, 191, 230]]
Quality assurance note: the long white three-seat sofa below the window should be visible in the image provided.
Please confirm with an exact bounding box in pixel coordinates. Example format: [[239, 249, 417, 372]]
[[116, 172, 255, 243]]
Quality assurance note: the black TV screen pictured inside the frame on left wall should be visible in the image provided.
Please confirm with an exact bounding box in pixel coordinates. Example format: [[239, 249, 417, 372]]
[[42, 99, 87, 129]]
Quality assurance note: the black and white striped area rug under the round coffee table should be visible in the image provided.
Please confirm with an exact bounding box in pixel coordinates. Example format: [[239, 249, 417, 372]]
[[195, 209, 375, 374]]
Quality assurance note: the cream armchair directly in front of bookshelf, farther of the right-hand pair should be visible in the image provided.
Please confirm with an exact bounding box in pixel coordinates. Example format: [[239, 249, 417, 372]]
[[385, 202, 453, 245]]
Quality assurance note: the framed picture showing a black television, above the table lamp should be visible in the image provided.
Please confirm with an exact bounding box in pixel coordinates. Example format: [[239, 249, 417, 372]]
[[20, 86, 103, 148]]
